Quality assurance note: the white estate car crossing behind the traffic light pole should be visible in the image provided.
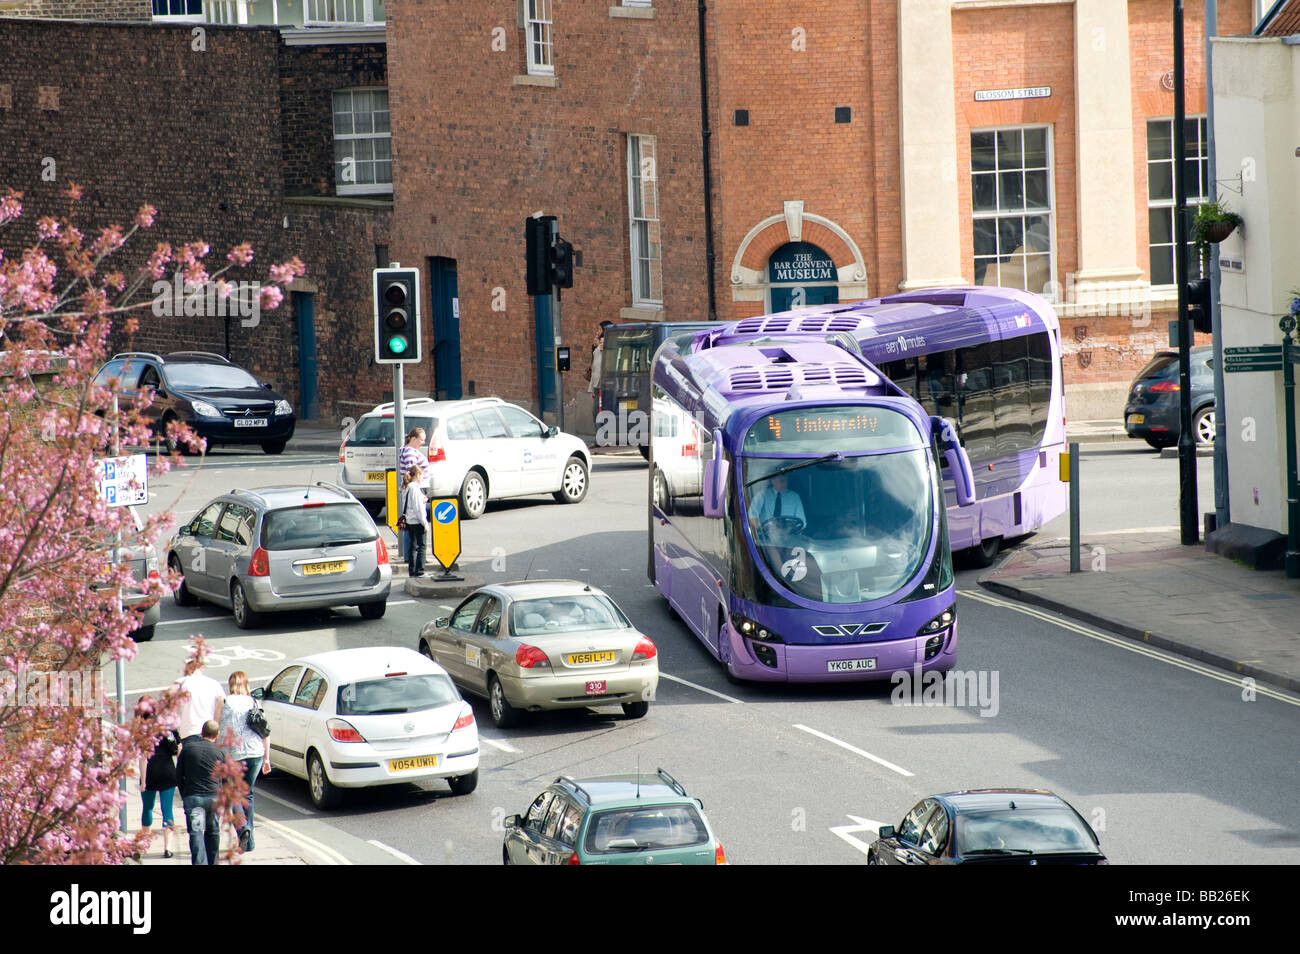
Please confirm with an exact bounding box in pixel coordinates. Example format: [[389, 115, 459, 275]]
[[338, 398, 592, 520]]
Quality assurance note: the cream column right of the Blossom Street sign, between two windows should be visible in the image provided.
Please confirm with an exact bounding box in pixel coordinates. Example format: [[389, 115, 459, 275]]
[[1074, 0, 1141, 302]]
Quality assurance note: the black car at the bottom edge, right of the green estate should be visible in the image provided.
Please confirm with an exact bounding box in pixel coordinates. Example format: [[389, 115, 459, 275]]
[[867, 789, 1108, 864]]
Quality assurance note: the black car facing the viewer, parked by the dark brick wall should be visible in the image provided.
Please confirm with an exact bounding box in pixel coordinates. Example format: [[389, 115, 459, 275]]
[[95, 351, 296, 454]]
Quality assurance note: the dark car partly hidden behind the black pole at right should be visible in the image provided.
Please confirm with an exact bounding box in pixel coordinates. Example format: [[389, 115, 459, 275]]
[[1125, 344, 1214, 448]]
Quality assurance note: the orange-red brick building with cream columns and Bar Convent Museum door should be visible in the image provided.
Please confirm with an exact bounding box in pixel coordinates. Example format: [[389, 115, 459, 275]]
[[387, 0, 1260, 429]]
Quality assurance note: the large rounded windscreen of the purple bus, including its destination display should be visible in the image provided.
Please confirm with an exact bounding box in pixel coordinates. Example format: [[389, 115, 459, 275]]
[[741, 408, 935, 603]]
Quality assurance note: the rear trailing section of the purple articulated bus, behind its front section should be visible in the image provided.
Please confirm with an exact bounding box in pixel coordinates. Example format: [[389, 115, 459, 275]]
[[712, 286, 1069, 567]]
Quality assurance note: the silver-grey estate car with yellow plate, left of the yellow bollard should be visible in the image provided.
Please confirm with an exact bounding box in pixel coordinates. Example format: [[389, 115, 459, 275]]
[[166, 481, 393, 629]]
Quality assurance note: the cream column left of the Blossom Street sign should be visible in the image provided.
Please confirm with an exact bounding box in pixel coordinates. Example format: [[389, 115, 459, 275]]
[[898, 0, 967, 290]]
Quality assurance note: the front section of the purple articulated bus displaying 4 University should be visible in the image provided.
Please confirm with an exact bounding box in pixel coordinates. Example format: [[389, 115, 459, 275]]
[[647, 324, 974, 682]]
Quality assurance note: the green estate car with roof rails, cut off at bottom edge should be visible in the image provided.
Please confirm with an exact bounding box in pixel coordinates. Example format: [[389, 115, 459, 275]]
[[501, 768, 727, 864]]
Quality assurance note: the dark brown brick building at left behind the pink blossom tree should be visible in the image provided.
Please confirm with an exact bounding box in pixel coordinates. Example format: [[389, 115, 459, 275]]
[[0, 0, 393, 421]]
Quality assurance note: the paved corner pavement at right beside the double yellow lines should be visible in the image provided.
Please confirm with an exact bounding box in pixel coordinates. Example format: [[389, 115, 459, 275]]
[[979, 528, 1300, 691]]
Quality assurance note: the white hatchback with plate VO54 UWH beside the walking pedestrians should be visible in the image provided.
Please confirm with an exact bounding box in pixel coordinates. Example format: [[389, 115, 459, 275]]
[[254, 646, 478, 808]]
